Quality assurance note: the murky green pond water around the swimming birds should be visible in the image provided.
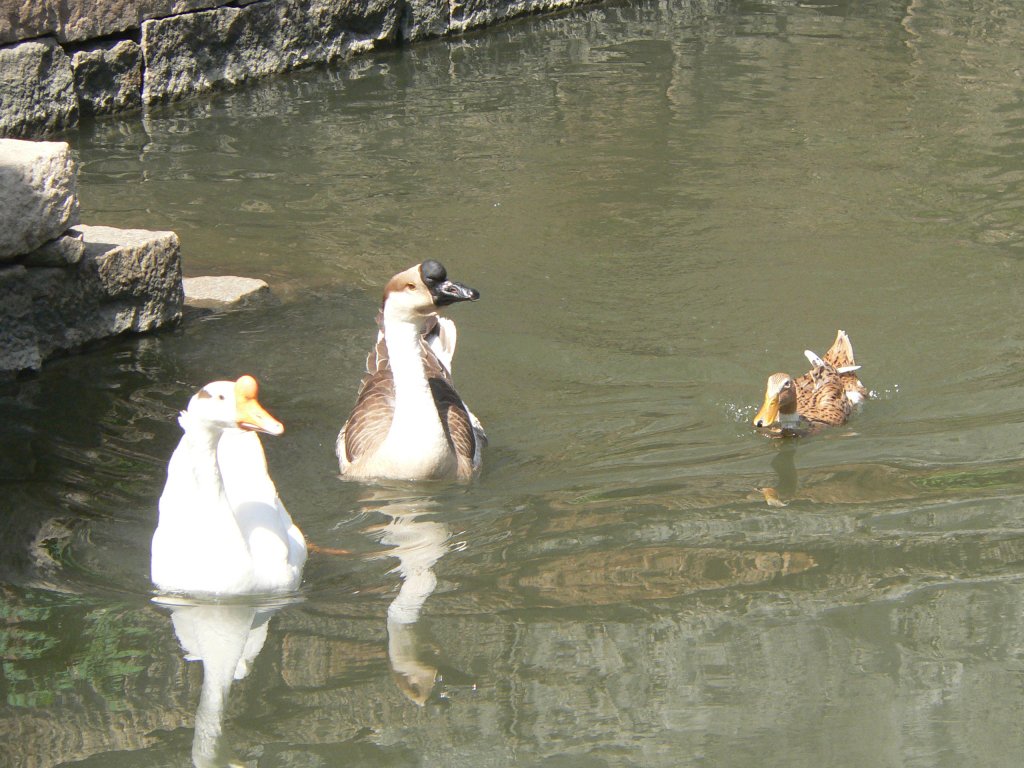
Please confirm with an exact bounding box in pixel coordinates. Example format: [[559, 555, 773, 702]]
[[0, 0, 1024, 768]]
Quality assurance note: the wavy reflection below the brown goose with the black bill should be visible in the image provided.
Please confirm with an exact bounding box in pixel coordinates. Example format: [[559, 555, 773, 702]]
[[370, 500, 451, 707]]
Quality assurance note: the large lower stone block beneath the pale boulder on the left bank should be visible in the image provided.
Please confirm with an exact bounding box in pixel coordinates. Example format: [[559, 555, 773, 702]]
[[0, 225, 183, 376]]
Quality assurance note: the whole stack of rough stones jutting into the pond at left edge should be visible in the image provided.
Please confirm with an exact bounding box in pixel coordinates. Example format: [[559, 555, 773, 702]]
[[0, 139, 183, 379]]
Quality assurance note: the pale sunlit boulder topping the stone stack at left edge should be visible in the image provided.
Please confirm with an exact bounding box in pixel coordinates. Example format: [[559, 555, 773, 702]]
[[0, 139, 78, 262]]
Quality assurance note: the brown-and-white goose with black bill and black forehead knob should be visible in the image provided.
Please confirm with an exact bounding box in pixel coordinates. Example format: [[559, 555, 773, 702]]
[[335, 260, 486, 480]]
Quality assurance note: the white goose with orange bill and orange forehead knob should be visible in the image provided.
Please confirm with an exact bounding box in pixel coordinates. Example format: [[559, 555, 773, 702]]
[[151, 376, 306, 595]]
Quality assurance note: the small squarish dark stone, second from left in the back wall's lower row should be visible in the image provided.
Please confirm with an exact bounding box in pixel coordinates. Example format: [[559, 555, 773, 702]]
[[72, 40, 142, 115]]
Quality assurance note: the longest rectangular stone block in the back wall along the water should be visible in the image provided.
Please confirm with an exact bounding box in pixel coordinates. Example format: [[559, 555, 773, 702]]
[[142, 0, 399, 103]]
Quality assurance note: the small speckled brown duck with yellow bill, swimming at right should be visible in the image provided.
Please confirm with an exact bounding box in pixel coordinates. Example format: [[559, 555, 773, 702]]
[[754, 331, 867, 436]]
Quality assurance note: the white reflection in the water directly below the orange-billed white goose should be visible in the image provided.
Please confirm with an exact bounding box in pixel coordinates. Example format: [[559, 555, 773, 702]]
[[156, 597, 287, 768]]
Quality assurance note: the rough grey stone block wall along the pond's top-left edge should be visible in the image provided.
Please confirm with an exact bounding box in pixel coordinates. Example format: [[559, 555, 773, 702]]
[[0, 0, 593, 137]]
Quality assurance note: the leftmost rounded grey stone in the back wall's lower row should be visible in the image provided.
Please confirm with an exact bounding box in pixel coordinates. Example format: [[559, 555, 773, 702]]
[[0, 38, 78, 138]]
